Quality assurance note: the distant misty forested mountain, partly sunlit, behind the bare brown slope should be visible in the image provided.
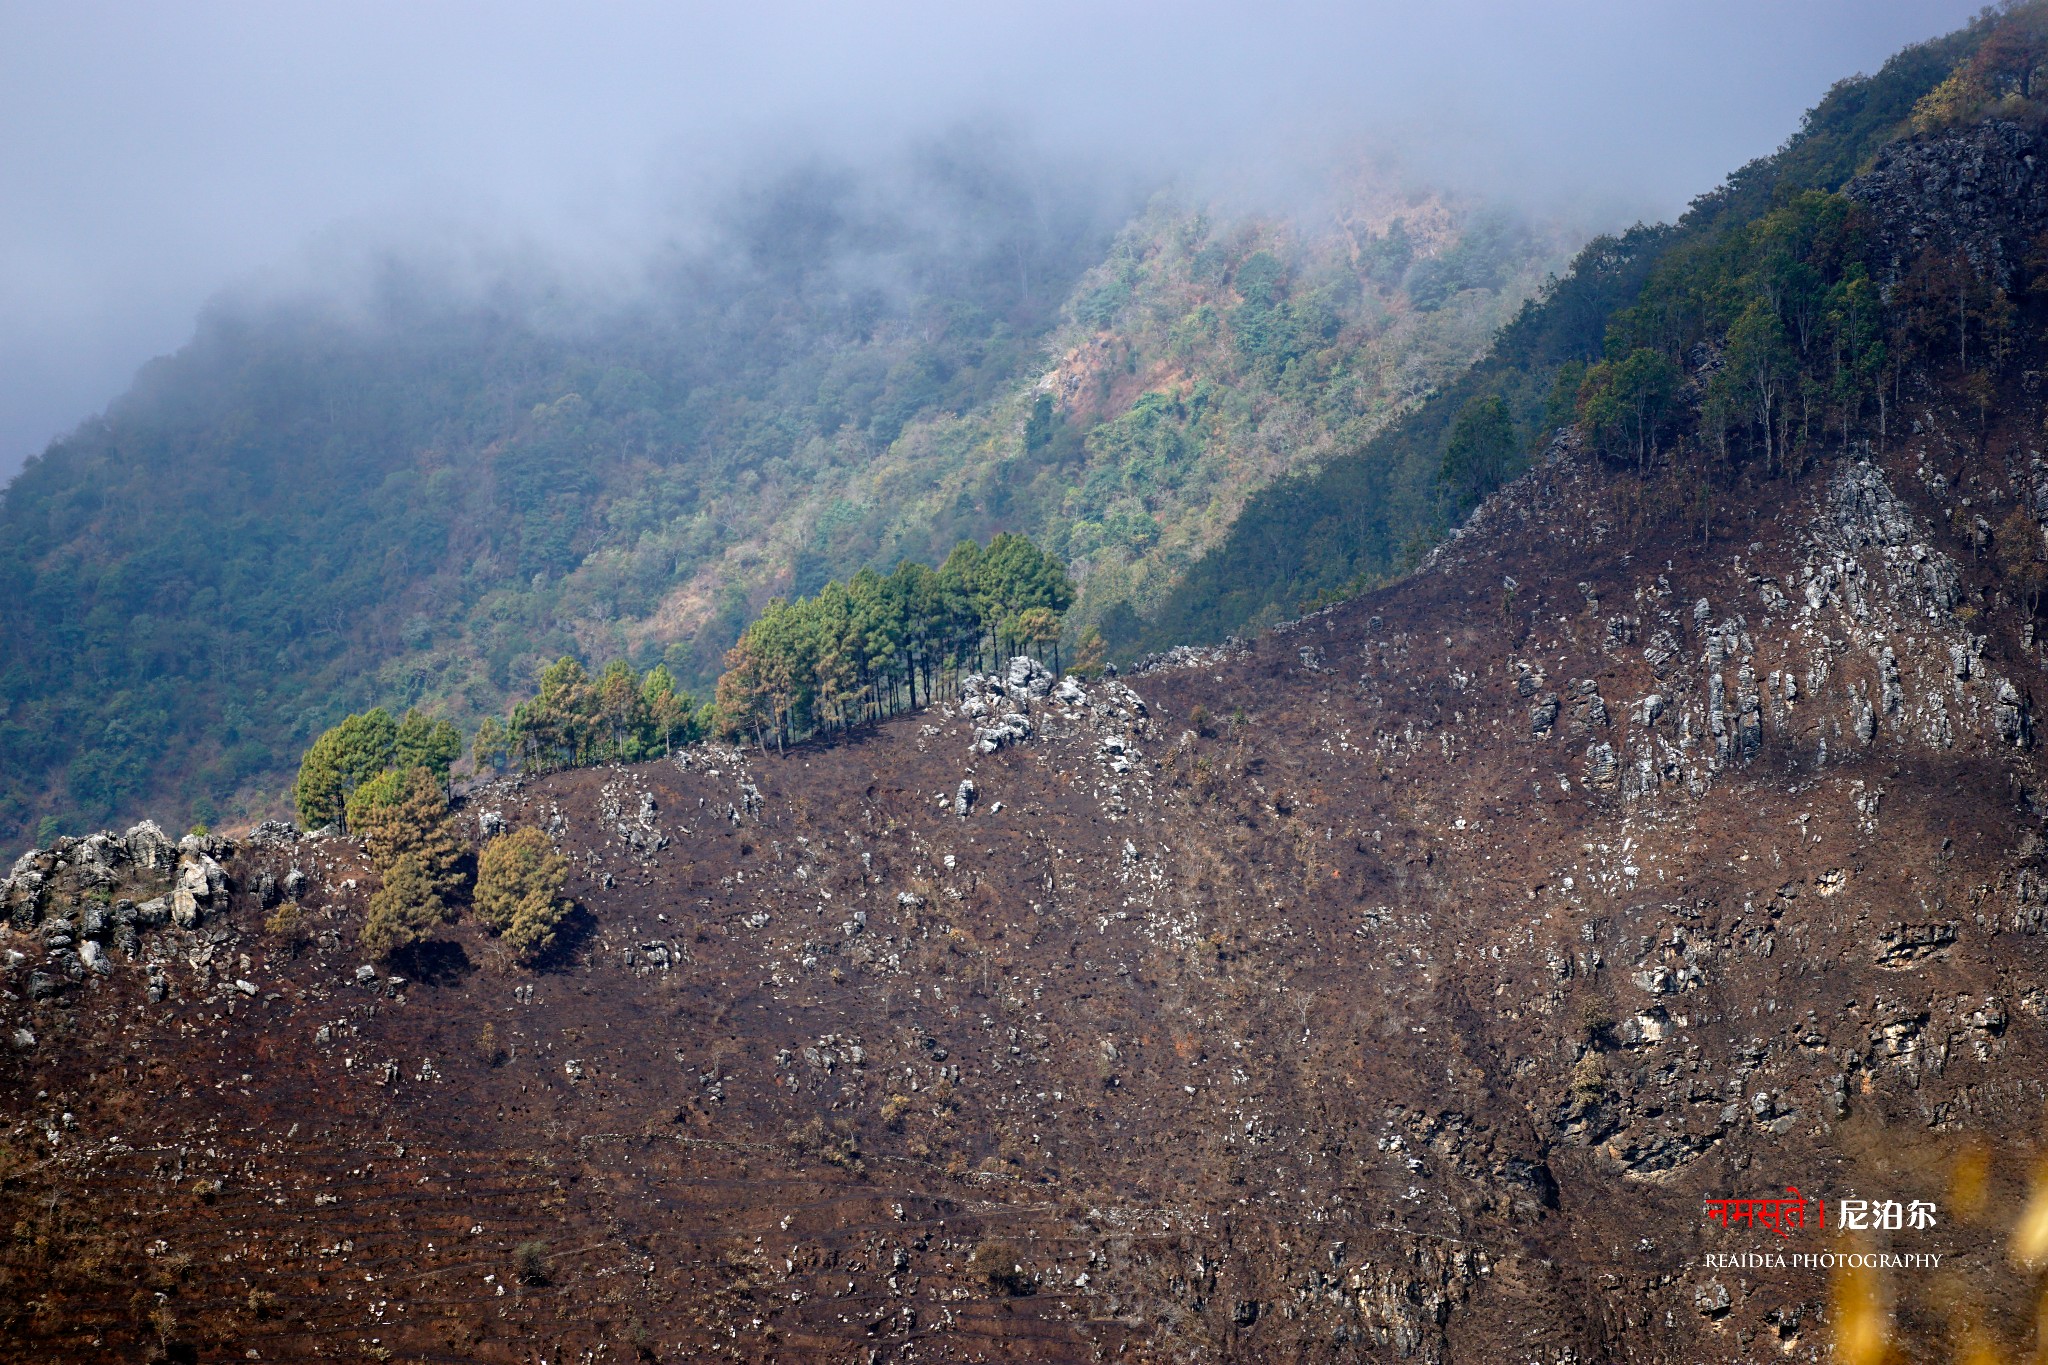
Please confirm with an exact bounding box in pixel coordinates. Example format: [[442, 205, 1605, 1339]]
[[0, 145, 1561, 843]]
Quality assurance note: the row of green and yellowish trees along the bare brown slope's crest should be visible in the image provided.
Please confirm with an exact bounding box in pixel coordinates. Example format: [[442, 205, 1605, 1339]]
[[293, 534, 1102, 962]]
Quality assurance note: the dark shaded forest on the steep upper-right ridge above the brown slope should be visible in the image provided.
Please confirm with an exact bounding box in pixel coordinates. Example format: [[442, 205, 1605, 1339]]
[[1143, 18, 1990, 649]]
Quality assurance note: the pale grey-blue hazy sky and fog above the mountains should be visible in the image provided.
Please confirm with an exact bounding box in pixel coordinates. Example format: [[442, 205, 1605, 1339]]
[[0, 0, 1978, 477]]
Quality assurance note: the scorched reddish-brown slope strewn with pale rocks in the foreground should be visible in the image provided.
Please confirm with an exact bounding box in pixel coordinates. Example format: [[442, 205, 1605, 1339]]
[[12, 136, 2048, 1363]]
